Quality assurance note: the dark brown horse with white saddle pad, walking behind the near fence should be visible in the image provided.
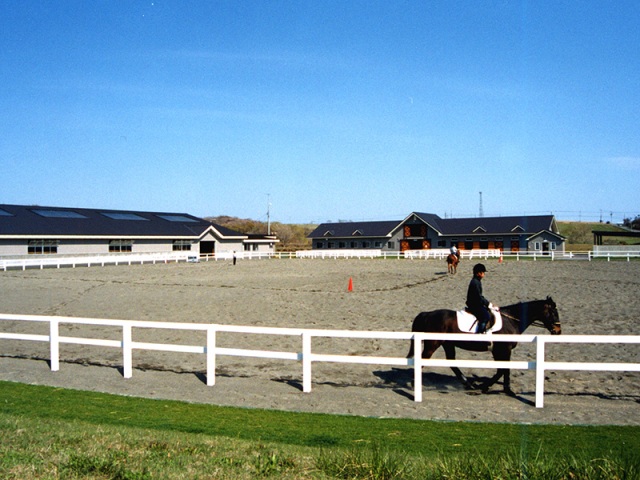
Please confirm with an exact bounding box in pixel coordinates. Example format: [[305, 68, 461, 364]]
[[407, 297, 562, 395]]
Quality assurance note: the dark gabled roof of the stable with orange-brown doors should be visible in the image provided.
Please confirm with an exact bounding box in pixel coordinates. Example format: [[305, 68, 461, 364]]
[[309, 212, 557, 238]]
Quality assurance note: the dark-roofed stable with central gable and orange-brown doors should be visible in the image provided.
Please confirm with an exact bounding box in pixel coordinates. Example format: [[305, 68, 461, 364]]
[[309, 212, 565, 254]]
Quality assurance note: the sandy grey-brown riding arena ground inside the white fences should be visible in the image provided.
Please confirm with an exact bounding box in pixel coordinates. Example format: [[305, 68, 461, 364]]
[[0, 259, 640, 425]]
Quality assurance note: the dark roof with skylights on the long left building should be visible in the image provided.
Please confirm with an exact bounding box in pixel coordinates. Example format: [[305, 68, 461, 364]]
[[0, 205, 245, 238]]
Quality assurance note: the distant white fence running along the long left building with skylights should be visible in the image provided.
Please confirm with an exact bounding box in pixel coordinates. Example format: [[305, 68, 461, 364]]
[[0, 252, 197, 272]]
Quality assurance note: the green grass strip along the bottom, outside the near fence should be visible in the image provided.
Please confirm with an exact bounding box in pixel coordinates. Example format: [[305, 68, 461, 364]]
[[0, 382, 640, 479]]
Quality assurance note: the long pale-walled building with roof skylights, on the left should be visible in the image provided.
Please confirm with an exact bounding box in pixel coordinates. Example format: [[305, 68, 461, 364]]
[[0, 205, 278, 257]]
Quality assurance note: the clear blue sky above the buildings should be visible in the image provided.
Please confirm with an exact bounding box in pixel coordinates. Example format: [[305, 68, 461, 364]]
[[0, 0, 640, 223]]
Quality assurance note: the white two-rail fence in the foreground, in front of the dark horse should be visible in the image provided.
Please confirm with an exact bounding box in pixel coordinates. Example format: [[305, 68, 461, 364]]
[[0, 314, 640, 408]]
